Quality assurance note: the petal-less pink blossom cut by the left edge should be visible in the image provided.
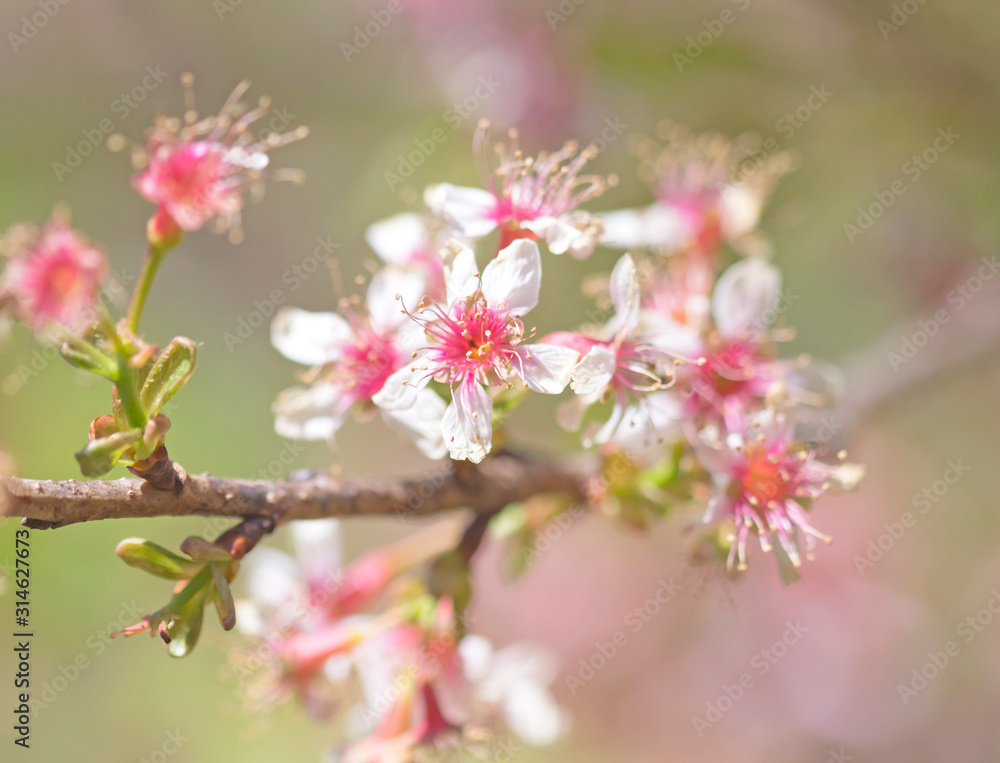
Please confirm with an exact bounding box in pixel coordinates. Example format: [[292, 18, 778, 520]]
[[0, 217, 108, 332]]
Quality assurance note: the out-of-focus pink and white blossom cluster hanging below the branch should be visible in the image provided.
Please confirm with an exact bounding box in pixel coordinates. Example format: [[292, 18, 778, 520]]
[[231, 520, 569, 763]]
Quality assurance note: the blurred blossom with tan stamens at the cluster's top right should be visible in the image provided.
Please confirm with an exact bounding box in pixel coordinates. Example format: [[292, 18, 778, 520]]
[[601, 123, 792, 256]]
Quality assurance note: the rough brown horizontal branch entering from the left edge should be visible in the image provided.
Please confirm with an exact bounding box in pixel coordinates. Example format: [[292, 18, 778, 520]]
[[0, 451, 581, 529]]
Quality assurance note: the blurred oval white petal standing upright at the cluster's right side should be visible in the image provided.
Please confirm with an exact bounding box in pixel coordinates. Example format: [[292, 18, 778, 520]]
[[712, 257, 781, 338]]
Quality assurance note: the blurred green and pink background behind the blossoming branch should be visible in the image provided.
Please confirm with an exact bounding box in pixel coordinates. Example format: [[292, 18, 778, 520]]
[[0, 0, 1000, 763]]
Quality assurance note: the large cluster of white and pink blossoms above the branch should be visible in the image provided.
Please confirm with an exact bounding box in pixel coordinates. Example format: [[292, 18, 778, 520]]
[[274, 125, 861, 570]]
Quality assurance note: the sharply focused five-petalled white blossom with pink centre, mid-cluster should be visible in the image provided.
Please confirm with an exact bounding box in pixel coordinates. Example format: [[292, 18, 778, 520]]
[[373, 239, 578, 463]]
